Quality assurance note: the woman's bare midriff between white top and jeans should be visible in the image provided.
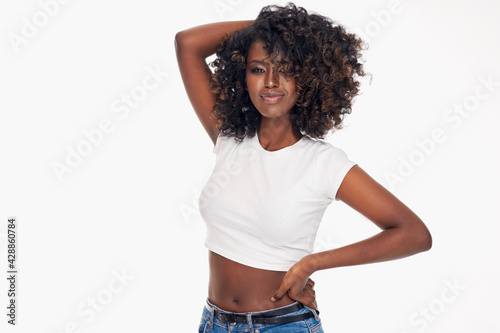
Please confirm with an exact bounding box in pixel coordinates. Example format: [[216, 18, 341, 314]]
[[208, 251, 295, 312]]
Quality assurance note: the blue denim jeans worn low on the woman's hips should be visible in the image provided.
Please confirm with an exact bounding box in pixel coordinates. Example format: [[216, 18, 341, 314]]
[[198, 299, 324, 333]]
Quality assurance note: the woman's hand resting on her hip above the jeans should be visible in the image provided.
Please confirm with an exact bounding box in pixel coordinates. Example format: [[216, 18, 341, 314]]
[[271, 259, 318, 310]]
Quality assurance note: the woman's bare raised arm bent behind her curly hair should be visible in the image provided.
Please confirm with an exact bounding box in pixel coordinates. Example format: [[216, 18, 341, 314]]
[[175, 20, 253, 145]]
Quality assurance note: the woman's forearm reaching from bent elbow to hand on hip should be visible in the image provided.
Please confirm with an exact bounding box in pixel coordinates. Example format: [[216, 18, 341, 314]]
[[303, 222, 432, 274]]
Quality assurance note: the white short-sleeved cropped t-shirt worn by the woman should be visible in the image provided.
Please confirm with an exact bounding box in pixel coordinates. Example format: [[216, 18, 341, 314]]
[[199, 134, 356, 271]]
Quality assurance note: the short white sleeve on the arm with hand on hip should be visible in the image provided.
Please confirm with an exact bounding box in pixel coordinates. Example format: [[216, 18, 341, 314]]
[[316, 143, 357, 201]]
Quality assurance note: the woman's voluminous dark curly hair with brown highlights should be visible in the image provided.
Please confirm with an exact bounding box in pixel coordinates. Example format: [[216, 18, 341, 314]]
[[210, 3, 365, 141]]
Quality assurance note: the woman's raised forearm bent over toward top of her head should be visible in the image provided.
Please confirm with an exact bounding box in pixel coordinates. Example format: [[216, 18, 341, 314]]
[[175, 20, 253, 59]]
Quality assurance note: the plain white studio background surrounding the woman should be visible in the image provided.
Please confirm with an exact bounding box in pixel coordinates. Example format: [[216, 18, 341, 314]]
[[0, 0, 500, 333]]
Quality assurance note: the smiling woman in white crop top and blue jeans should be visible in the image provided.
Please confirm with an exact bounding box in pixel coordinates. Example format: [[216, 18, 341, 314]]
[[176, 4, 432, 332]]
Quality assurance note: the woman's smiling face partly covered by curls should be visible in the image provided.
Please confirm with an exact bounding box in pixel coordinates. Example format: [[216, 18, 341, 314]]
[[245, 41, 298, 118]]
